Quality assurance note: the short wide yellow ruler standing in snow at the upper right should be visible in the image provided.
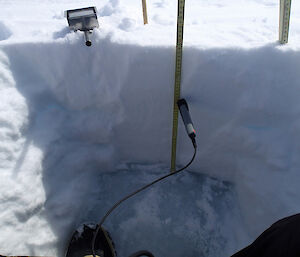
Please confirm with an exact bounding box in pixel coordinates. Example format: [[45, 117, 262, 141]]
[[279, 0, 292, 44]]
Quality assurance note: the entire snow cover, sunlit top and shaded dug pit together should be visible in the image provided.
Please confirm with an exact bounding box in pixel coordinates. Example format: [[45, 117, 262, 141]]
[[0, 0, 300, 257]]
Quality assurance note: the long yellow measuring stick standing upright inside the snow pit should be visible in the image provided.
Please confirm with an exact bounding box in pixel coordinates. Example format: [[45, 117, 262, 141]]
[[171, 0, 185, 172]]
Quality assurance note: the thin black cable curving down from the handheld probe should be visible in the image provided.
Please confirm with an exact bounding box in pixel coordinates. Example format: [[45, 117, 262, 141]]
[[92, 144, 197, 257]]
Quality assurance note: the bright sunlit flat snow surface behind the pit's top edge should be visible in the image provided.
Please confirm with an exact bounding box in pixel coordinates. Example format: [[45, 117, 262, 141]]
[[0, 0, 300, 49]]
